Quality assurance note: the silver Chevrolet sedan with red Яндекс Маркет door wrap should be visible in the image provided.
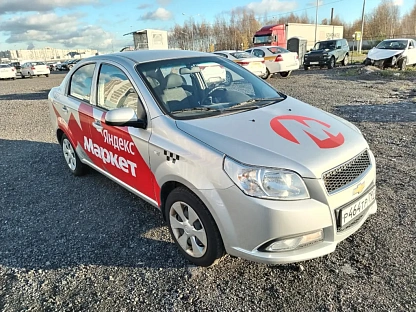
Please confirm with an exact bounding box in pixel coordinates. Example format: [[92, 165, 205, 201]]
[[48, 50, 377, 266]]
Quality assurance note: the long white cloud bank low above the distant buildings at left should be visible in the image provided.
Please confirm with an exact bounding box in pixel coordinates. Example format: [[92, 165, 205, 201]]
[[0, 13, 113, 50]]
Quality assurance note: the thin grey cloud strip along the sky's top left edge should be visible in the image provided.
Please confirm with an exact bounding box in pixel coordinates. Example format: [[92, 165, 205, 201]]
[[0, 0, 98, 14]]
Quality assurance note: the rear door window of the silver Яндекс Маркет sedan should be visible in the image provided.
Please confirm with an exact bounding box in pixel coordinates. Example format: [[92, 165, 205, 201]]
[[69, 64, 95, 103]]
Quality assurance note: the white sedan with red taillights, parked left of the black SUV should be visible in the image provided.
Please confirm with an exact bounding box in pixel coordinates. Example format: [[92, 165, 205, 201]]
[[246, 46, 299, 79]]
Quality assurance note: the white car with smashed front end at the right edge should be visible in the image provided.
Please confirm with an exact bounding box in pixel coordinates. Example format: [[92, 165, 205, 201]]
[[364, 39, 416, 70]]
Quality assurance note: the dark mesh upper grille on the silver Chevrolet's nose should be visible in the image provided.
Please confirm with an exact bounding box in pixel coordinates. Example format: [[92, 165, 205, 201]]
[[323, 150, 371, 194]]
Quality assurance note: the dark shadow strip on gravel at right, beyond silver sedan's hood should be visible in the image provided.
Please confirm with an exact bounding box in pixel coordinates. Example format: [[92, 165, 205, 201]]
[[333, 102, 416, 123]]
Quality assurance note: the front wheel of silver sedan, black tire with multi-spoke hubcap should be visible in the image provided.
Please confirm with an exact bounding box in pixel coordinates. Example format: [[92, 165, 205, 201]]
[[165, 187, 224, 267]]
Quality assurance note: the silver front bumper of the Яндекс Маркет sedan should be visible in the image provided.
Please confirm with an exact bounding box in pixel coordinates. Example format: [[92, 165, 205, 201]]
[[201, 163, 377, 264]]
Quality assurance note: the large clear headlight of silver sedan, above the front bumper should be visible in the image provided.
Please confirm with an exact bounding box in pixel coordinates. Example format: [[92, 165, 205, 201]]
[[224, 157, 309, 200]]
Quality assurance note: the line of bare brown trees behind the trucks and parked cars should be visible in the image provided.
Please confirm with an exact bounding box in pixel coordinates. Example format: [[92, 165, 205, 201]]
[[168, 0, 416, 52]]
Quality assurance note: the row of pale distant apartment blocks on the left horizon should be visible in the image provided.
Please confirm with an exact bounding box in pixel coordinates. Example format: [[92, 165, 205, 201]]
[[0, 48, 98, 61]]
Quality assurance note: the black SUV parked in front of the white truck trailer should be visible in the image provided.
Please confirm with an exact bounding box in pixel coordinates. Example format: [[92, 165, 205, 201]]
[[303, 39, 350, 70]]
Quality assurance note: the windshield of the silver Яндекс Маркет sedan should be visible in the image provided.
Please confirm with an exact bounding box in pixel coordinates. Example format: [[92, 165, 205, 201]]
[[136, 56, 286, 119]]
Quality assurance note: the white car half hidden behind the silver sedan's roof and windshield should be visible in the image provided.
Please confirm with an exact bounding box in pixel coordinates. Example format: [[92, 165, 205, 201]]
[[214, 50, 267, 77]]
